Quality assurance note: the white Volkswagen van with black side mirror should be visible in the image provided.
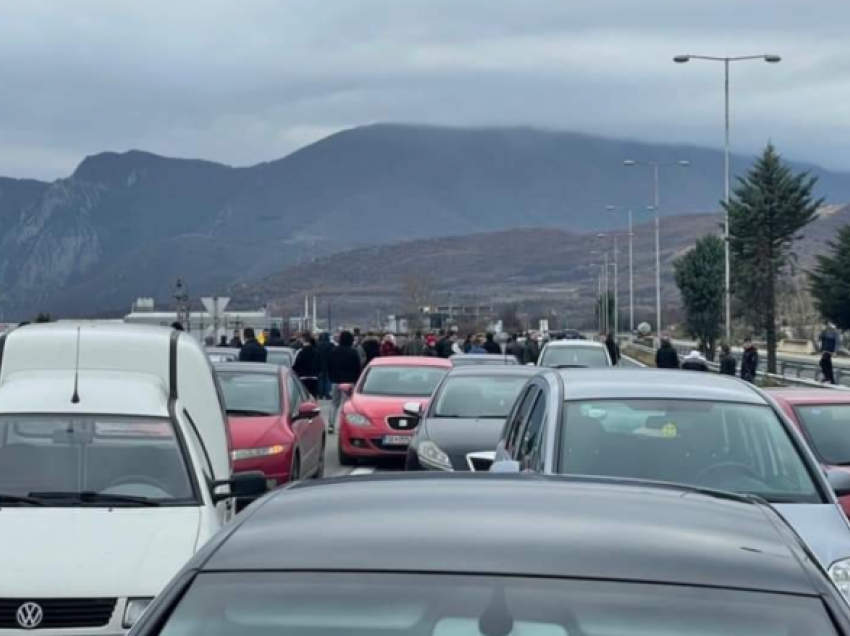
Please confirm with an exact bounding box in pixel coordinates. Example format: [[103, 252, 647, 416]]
[[0, 323, 265, 636]]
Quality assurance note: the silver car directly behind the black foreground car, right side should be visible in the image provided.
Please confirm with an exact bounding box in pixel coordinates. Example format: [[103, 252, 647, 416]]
[[491, 369, 850, 597]]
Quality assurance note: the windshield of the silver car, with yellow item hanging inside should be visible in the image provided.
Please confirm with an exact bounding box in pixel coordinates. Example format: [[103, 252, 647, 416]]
[[559, 399, 822, 503]]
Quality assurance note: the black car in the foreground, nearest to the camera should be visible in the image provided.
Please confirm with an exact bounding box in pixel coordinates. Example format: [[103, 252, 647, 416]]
[[130, 473, 850, 636]]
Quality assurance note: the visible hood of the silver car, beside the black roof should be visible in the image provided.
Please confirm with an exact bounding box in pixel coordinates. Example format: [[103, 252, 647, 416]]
[[773, 504, 850, 568]]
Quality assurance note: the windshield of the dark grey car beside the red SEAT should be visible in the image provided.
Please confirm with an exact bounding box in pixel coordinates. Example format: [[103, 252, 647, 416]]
[[434, 376, 528, 420]]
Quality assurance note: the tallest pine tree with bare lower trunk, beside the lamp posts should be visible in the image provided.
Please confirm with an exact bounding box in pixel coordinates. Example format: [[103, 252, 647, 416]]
[[724, 144, 823, 373]]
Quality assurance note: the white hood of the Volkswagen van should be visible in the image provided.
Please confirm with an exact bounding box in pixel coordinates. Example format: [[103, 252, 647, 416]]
[[0, 507, 200, 598]]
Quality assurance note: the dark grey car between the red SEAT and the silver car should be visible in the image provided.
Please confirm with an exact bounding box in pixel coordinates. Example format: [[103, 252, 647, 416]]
[[406, 366, 538, 471]]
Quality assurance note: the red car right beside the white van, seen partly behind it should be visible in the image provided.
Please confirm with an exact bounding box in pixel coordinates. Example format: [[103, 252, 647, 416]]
[[215, 362, 326, 488]]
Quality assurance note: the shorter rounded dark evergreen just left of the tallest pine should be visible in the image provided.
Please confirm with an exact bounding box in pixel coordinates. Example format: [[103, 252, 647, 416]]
[[673, 235, 725, 360]]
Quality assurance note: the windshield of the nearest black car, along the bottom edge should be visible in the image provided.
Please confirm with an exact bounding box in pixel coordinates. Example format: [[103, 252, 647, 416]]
[[158, 572, 836, 636]]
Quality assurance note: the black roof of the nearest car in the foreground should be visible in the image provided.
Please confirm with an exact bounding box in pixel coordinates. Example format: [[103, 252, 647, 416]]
[[200, 473, 817, 594]]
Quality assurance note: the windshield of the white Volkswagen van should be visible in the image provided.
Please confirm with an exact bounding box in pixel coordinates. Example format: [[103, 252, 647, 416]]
[[0, 415, 195, 506]]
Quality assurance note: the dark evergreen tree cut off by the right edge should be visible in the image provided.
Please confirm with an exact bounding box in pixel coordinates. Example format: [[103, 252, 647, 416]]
[[809, 225, 850, 331]]
